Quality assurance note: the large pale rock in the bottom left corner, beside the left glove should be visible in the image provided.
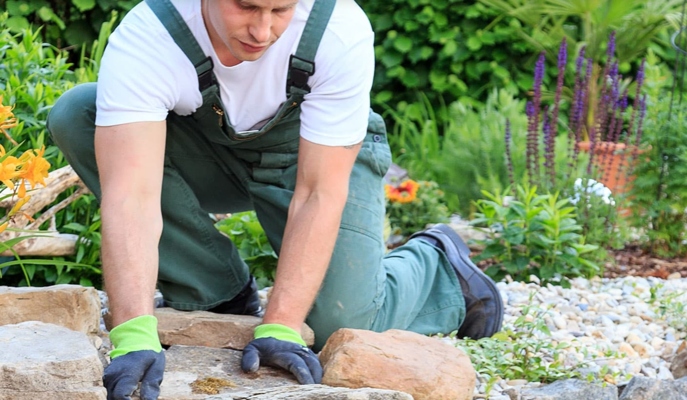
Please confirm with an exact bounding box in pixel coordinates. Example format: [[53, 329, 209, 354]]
[[0, 321, 106, 400]]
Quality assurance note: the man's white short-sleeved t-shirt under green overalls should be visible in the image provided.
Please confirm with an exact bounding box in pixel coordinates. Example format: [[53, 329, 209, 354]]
[[96, 0, 374, 146]]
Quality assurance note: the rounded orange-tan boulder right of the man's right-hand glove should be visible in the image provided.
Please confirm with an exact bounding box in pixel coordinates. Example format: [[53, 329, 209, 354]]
[[320, 329, 476, 400]]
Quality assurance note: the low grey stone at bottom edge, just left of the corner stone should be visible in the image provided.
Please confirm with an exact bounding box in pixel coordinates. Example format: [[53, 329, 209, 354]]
[[521, 379, 618, 400]]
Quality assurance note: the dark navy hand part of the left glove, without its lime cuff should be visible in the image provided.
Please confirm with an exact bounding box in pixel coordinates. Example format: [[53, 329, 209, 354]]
[[103, 350, 165, 400]]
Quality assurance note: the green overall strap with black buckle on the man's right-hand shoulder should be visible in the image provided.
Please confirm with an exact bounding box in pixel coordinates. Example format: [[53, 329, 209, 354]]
[[286, 0, 336, 97]]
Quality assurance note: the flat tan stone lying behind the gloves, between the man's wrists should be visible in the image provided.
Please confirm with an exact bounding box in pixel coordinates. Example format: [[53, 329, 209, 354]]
[[155, 308, 315, 350]]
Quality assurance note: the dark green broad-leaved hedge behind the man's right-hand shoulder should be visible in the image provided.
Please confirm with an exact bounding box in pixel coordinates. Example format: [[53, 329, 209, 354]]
[[361, 0, 534, 107]]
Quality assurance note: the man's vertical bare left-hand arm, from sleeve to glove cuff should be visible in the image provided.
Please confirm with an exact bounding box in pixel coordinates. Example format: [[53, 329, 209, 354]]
[[95, 121, 166, 326]]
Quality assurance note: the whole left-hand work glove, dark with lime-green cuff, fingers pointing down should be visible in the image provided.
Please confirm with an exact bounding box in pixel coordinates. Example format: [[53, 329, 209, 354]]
[[103, 315, 165, 400]]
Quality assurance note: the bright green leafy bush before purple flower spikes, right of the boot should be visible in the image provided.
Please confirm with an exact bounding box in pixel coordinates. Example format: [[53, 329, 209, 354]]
[[471, 185, 600, 287]]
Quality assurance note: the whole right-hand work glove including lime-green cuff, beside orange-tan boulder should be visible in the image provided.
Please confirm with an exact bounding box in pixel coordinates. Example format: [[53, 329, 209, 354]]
[[241, 324, 322, 384]]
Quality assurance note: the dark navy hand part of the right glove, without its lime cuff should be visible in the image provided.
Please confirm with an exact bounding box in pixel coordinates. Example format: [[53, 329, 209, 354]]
[[241, 337, 322, 384]]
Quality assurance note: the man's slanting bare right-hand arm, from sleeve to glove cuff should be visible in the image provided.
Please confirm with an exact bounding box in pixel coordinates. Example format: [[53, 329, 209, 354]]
[[263, 139, 361, 332]]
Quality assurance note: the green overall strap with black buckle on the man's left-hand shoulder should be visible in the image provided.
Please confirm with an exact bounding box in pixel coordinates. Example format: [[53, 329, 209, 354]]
[[145, 0, 217, 97]]
